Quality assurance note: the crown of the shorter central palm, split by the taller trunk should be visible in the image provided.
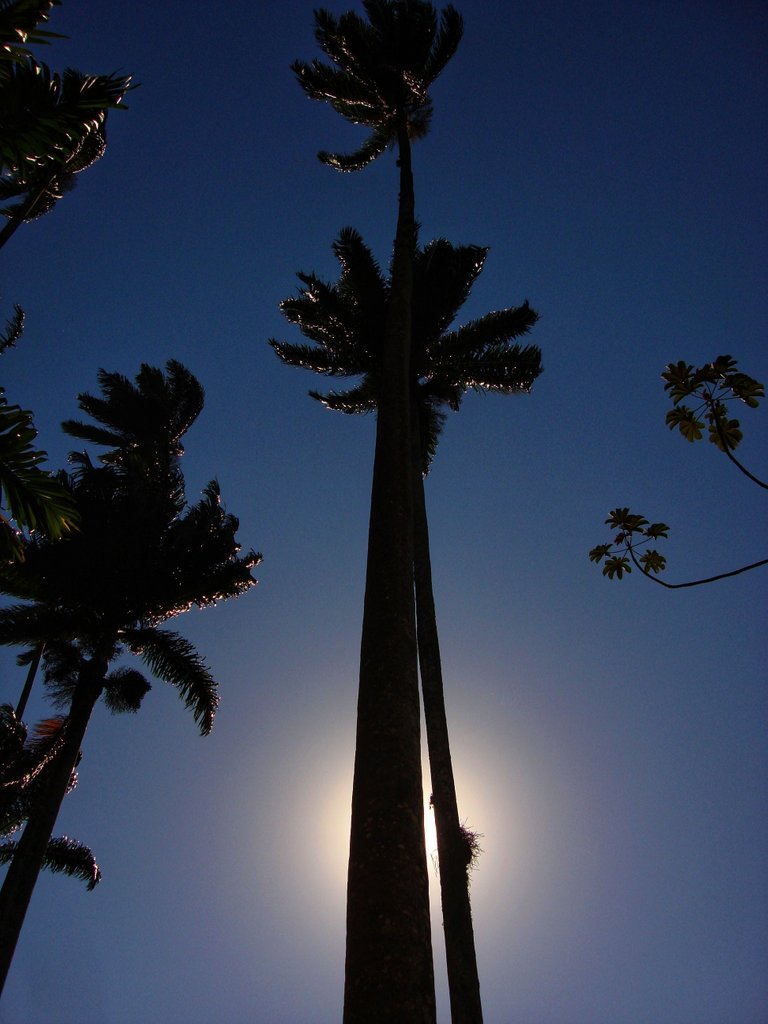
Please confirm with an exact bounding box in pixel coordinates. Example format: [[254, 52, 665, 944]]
[[269, 227, 542, 471]]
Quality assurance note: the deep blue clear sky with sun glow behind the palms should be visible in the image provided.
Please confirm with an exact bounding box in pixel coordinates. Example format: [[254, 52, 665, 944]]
[[0, 0, 768, 1024]]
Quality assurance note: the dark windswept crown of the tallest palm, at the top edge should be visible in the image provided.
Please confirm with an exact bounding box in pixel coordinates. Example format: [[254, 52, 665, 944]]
[[292, 0, 463, 171]]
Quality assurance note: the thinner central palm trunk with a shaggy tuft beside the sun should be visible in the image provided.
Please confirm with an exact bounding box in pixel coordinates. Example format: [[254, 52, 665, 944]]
[[412, 432, 482, 1024]]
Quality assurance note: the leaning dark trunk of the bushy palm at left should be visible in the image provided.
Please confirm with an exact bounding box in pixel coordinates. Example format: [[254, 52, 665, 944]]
[[0, 662, 106, 992]]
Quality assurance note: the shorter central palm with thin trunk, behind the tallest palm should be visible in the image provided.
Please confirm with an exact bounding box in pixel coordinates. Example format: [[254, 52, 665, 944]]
[[270, 228, 541, 1024]]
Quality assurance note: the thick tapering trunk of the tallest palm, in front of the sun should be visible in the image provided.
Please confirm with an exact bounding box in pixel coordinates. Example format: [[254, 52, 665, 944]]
[[344, 118, 435, 1024]]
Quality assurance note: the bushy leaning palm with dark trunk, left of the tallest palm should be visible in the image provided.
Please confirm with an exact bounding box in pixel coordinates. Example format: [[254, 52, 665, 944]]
[[0, 361, 260, 982]]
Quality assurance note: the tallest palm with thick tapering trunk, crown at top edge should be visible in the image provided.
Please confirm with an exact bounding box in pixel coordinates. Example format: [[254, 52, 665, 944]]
[[293, 6, 462, 1024]]
